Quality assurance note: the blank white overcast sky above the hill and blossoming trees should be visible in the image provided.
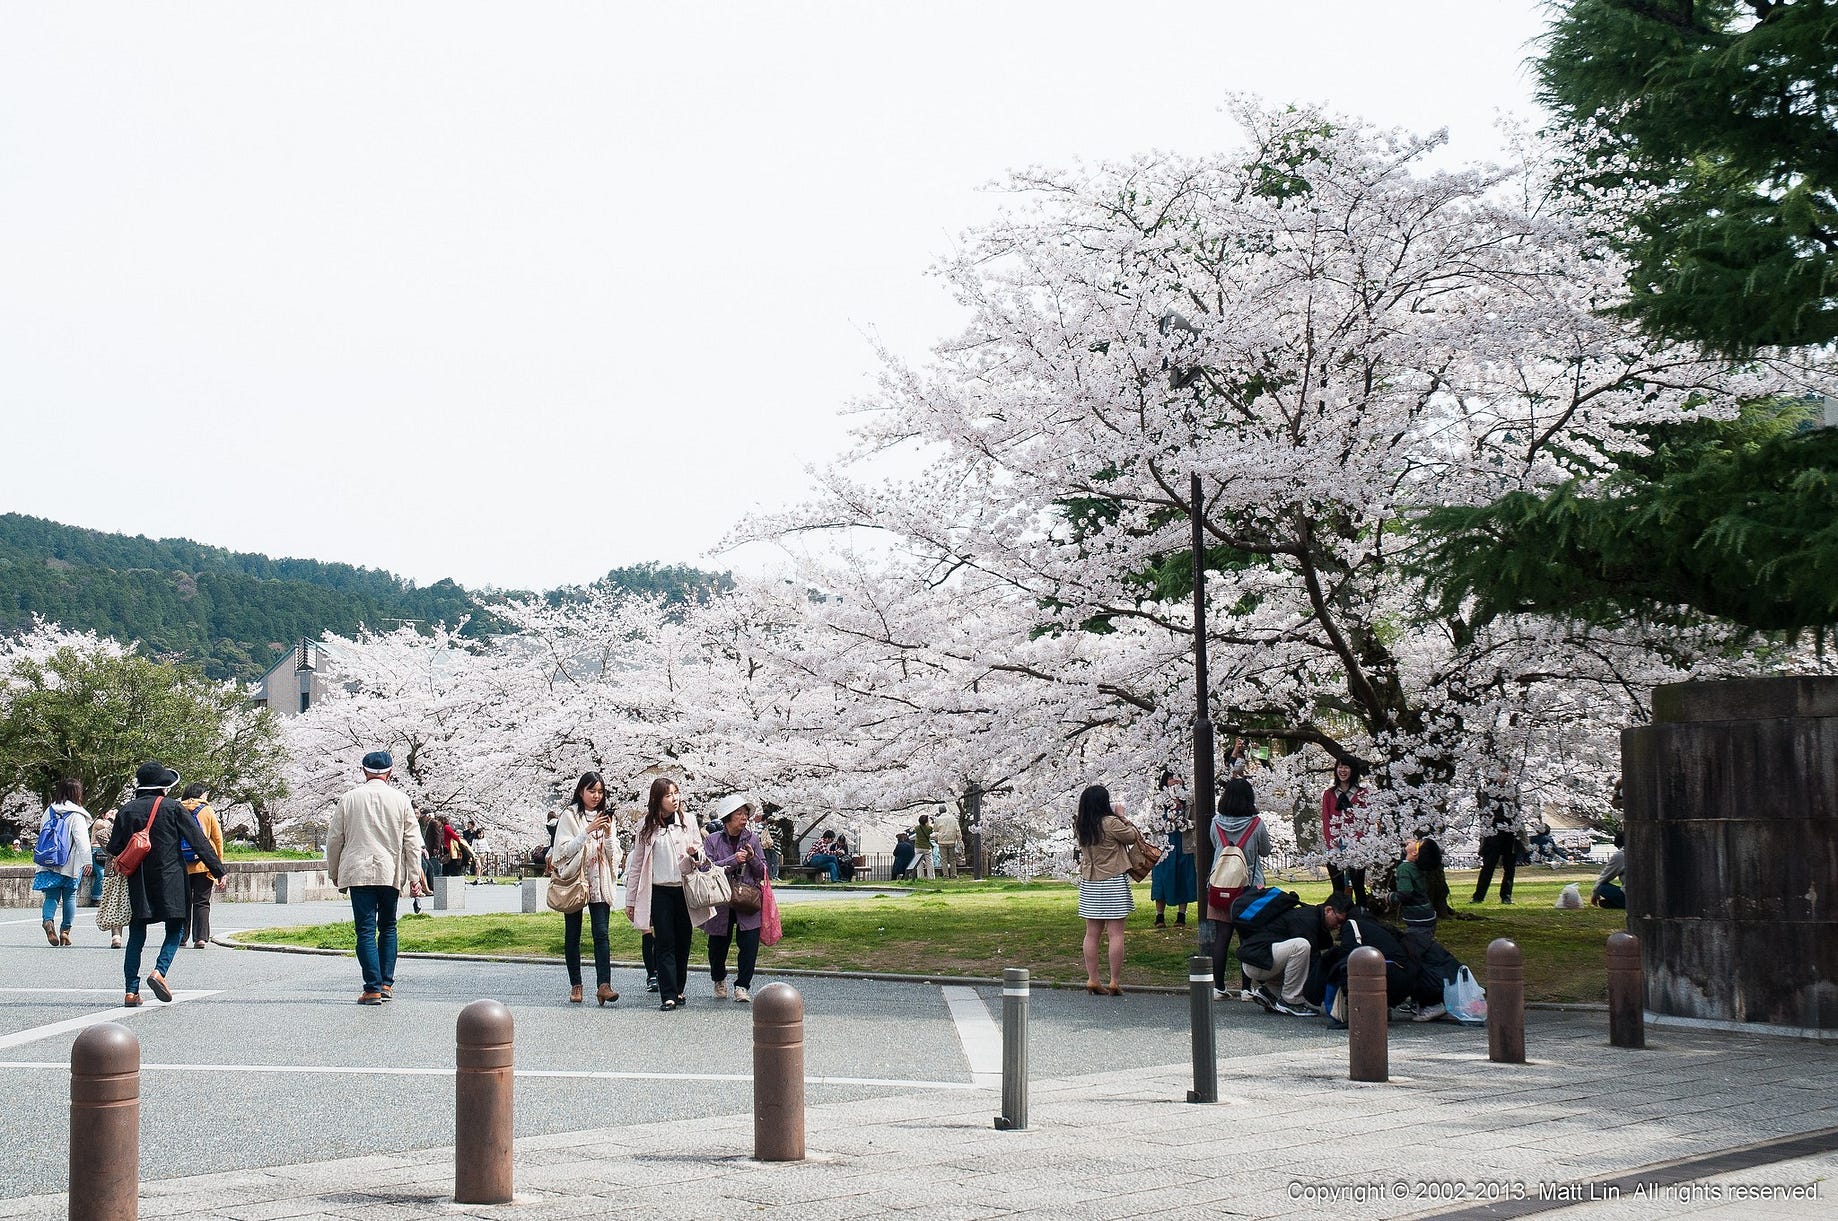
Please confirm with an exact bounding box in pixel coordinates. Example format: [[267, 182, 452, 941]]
[[0, 0, 1542, 587]]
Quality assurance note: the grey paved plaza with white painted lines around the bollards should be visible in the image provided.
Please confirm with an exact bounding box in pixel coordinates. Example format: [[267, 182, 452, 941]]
[[0, 888, 1838, 1221]]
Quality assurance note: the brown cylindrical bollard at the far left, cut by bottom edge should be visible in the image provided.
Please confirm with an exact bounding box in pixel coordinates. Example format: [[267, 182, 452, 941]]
[[70, 1022, 140, 1221]]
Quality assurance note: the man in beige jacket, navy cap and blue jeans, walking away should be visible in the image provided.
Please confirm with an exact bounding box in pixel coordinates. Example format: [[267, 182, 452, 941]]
[[325, 750, 423, 1004]]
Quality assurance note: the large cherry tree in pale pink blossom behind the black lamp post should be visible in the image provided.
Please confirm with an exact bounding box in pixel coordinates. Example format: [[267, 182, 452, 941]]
[[735, 103, 1831, 862]]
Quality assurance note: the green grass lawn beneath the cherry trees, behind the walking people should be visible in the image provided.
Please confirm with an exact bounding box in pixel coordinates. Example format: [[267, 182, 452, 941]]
[[243, 870, 1627, 1002]]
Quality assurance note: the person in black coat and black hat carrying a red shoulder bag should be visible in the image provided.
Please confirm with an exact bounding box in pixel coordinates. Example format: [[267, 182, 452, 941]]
[[108, 763, 224, 1006]]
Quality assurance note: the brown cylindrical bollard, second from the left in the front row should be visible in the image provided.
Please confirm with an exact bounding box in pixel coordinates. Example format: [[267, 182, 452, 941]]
[[454, 1000, 516, 1204]]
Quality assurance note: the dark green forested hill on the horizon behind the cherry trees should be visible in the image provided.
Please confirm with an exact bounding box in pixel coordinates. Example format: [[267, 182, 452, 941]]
[[0, 513, 728, 680]]
